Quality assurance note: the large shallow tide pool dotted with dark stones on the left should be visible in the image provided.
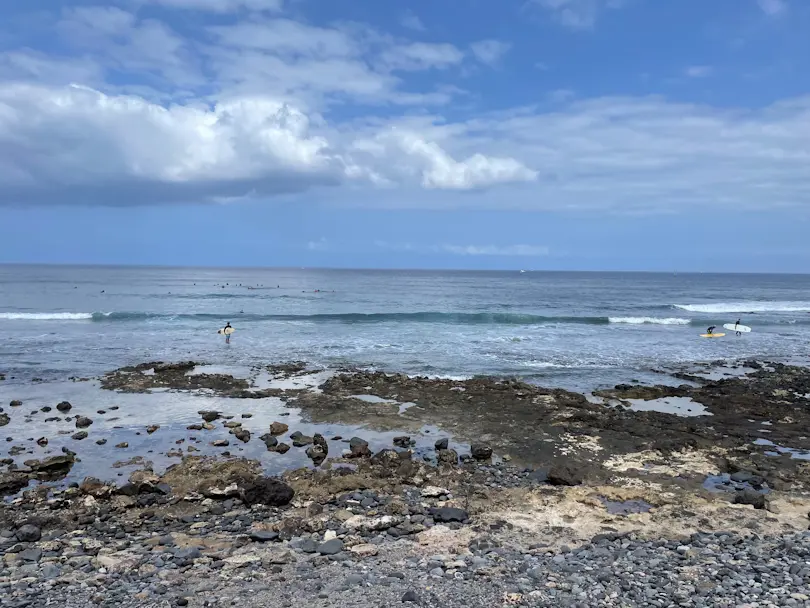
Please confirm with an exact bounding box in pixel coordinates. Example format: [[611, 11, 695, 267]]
[[0, 378, 458, 492]]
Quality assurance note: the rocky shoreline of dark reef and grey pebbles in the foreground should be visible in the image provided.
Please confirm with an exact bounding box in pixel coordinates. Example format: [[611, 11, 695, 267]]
[[0, 362, 810, 607]]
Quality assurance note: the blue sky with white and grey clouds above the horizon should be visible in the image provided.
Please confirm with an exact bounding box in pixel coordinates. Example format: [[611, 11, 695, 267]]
[[0, 0, 810, 272]]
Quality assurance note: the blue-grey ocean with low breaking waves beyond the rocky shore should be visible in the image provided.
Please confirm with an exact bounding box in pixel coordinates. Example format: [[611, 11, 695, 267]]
[[0, 266, 810, 393]]
